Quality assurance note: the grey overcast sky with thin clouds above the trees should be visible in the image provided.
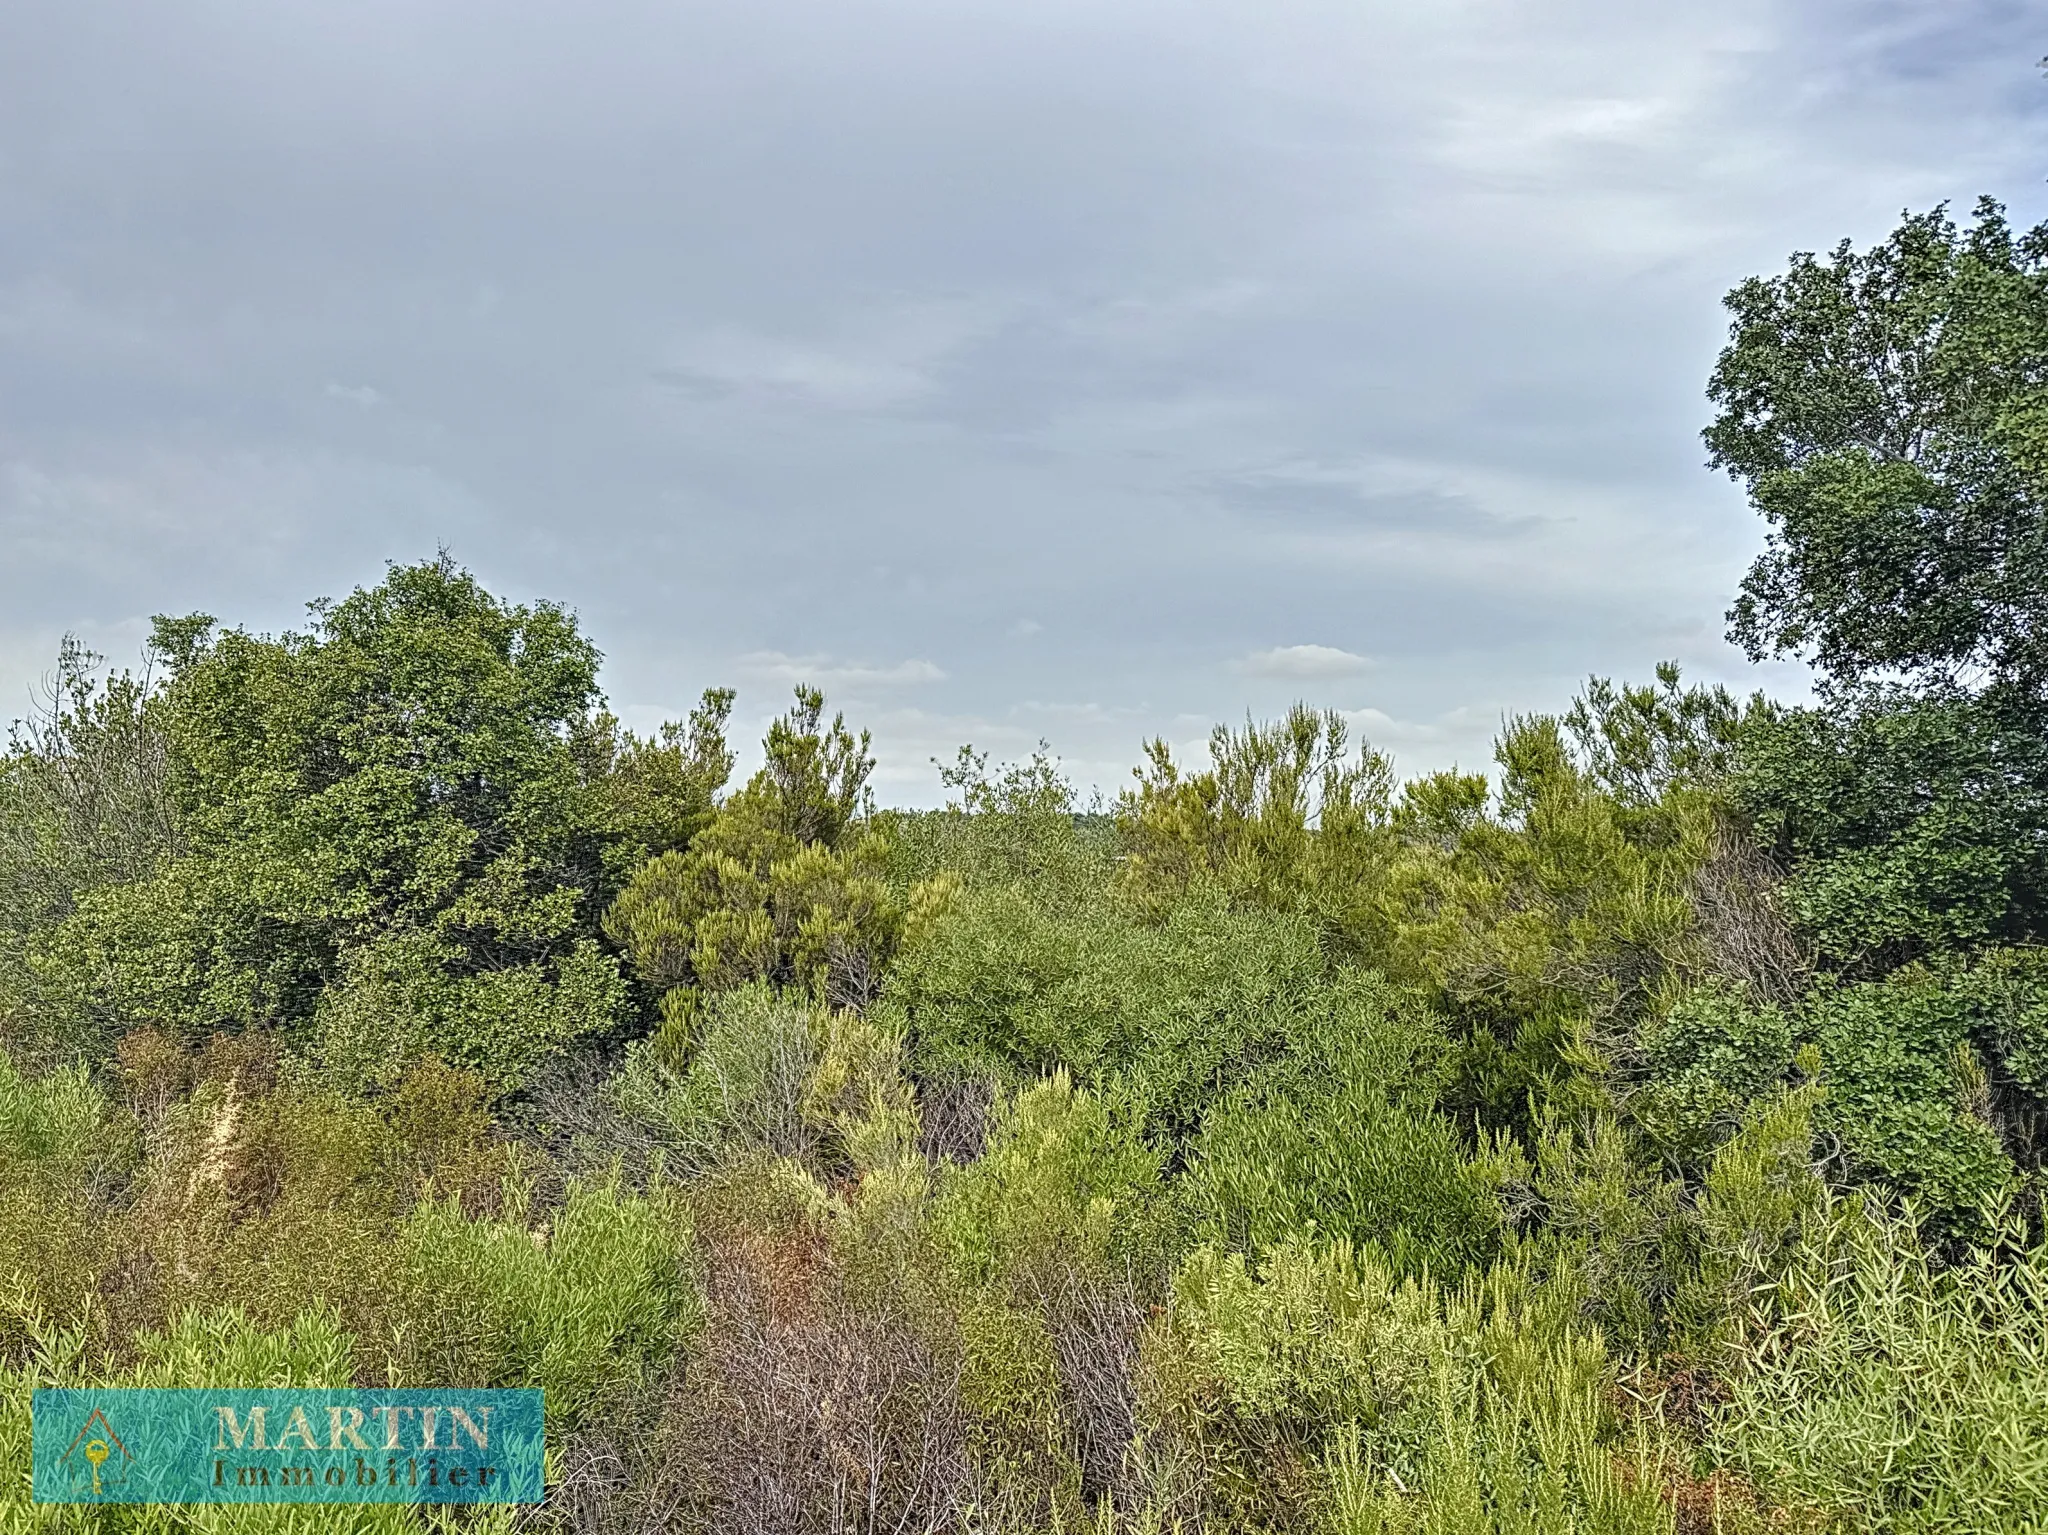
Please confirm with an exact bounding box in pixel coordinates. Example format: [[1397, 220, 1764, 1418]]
[[0, 0, 2048, 804]]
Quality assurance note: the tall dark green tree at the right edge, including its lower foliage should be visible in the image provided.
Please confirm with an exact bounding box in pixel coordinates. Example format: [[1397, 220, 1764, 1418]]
[[1706, 201, 2048, 968]]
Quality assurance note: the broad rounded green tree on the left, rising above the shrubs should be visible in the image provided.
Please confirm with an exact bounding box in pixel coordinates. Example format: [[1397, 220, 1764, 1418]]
[[12, 557, 731, 1087]]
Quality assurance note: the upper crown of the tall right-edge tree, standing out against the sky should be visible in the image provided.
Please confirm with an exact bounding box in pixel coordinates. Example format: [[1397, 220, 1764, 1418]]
[[1704, 199, 2048, 698]]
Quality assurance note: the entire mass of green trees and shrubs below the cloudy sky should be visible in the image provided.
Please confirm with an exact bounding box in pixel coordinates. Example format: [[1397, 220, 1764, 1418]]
[[12, 205, 2048, 1535]]
